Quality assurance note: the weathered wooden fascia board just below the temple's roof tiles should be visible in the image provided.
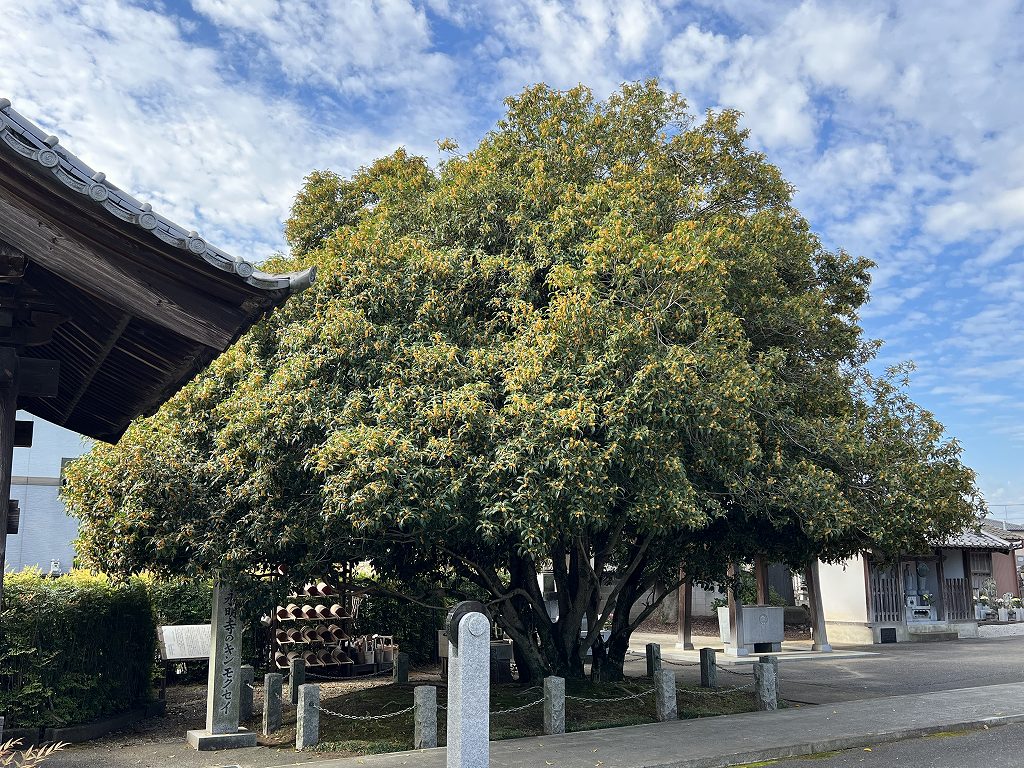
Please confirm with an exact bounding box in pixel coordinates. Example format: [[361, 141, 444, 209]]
[[0, 187, 244, 350]]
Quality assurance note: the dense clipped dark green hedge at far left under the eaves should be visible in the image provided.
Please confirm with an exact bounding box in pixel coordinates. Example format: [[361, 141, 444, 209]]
[[0, 570, 156, 727]]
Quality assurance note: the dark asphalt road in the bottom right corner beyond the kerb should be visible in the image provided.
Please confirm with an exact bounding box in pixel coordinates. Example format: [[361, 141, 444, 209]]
[[768, 724, 1024, 768]]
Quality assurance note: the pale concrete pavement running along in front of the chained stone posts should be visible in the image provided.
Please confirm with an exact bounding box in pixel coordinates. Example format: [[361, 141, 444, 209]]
[[270, 684, 1024, 768]]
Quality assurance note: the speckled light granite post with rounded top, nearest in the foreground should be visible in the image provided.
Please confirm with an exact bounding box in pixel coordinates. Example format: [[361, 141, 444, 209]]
[[447, 601, 490, 768]]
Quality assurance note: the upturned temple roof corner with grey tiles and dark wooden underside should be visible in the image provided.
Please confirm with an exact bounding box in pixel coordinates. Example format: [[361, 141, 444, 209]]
[[0, 98, 314, 441]]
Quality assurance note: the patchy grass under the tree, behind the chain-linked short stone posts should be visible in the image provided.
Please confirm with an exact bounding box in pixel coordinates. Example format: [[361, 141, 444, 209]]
[[276, 678, 754, 756]]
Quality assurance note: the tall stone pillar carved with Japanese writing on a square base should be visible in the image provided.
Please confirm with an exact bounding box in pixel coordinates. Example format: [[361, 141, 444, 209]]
[[185, 579, 256, 751]]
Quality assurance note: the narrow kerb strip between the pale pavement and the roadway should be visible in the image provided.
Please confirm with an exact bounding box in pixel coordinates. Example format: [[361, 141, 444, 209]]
[[644, 713, 1024, 768]]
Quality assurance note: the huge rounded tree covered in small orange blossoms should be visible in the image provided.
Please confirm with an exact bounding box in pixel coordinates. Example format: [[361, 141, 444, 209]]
[[66, 83, 978, 678]]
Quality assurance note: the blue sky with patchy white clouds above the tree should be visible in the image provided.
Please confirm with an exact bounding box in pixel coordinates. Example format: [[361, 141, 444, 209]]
[[0, 0, 1024, 521]]
